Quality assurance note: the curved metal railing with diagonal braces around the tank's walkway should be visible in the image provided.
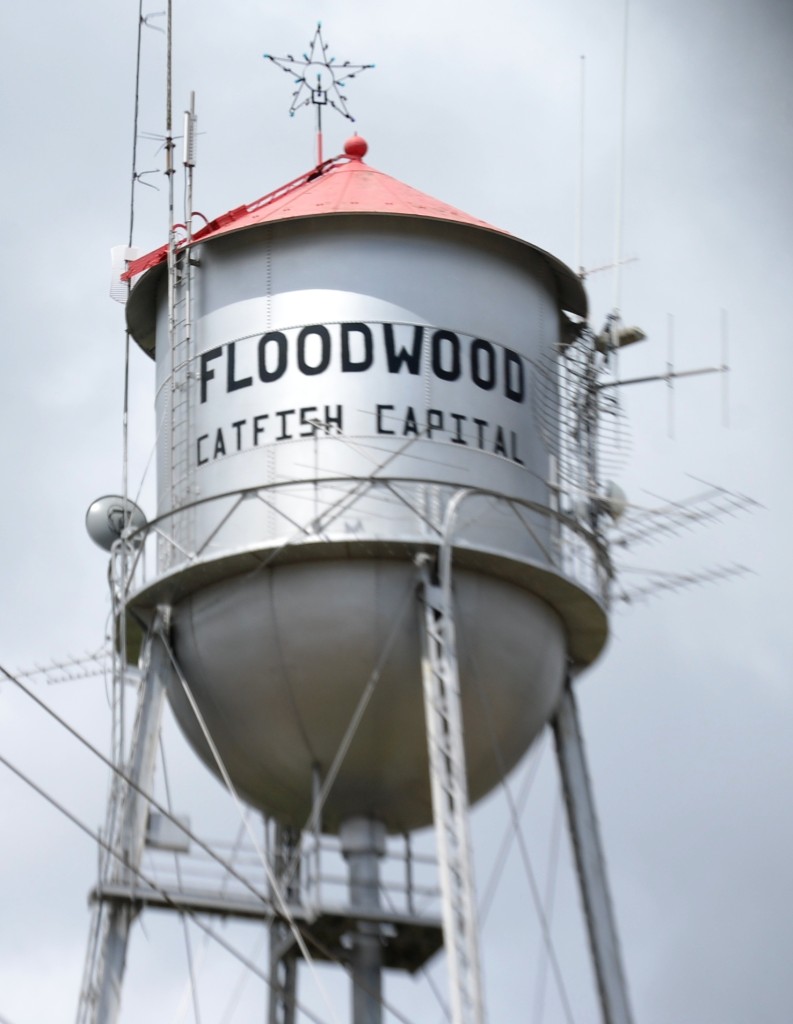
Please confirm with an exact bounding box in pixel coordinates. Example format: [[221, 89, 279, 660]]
[[119, 477, 613, 605]]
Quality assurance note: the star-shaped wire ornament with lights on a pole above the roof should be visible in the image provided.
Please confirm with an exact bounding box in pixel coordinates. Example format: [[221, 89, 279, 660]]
[[263, 22, 374, 163]]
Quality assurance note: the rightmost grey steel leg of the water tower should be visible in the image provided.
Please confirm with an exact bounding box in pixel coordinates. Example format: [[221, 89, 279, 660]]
[[552, 680, 633, 1024]]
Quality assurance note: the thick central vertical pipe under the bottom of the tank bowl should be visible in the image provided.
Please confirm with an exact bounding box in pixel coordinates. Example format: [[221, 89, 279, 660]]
[[339, 818, 385, 1024]]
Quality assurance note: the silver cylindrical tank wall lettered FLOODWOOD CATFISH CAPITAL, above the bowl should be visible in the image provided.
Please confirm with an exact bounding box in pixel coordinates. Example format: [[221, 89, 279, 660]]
[[157, 216, 558, 566]]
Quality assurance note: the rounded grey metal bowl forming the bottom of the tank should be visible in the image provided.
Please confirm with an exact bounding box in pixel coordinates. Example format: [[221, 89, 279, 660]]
[[169, 559, 567, 833]]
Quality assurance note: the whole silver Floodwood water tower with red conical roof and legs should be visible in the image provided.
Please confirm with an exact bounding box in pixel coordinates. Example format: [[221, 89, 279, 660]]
[[80, 75, 630, 1024]]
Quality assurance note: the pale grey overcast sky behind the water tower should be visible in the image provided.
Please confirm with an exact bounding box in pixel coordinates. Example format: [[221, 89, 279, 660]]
[[0, 0, 793, 1024]]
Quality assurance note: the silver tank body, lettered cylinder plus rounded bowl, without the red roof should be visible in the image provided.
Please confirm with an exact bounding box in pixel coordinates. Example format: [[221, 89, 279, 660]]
[[128, 155, 606, 830]]
